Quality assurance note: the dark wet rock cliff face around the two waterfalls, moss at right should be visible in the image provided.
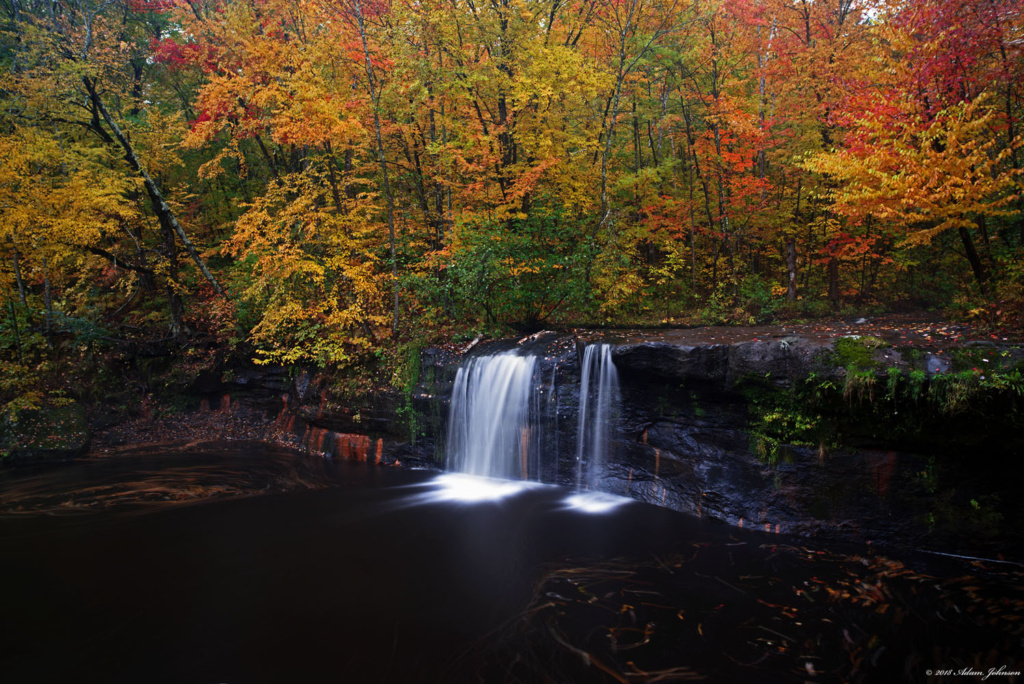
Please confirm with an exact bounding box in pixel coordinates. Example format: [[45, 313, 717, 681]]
[[230, 334, 1024, 553]]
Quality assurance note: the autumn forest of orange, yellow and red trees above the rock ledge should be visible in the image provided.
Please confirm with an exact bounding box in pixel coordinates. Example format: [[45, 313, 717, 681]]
[[0, 0, 1024, 409]]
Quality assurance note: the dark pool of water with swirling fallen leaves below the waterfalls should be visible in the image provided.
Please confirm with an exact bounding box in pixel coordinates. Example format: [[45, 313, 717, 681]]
[[0, 444, 1021, 684]]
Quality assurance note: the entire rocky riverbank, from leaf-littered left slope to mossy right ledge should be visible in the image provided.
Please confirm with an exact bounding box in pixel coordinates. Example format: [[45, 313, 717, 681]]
[[4, 315, 1024, 557]]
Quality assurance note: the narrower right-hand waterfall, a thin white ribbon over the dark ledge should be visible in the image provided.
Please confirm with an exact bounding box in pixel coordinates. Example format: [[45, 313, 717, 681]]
[[577, 344, 620, 487]]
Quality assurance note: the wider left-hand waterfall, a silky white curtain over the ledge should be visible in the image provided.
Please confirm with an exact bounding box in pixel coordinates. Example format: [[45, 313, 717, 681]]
[[447, 351, 540, 479]]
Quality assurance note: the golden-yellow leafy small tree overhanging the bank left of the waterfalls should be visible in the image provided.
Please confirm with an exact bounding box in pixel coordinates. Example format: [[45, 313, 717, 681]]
[[224, 166, 390, 366]]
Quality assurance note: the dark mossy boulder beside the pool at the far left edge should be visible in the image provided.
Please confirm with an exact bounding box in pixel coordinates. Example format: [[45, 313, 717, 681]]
[[0, 403, 91, 463]]
